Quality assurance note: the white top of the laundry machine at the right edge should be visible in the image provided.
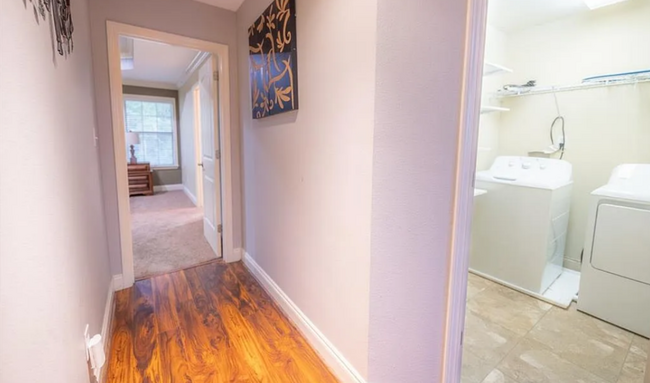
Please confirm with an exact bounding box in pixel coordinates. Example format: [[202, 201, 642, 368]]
[[591, 164, 650, 202]]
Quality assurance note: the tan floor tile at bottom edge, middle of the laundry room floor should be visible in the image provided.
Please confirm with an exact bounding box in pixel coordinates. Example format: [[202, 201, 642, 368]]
[[498, 339, 607, 383]]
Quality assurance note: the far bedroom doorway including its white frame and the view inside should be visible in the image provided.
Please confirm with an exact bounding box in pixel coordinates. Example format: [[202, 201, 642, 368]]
[[108, 22, 235, 287]]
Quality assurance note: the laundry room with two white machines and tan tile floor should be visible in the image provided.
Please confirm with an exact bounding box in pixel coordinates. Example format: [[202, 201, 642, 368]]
[[463, 0, 650, 383]]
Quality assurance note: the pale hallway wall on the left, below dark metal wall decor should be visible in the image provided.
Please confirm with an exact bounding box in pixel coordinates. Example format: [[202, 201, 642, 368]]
[[0, 0, 111, 383]]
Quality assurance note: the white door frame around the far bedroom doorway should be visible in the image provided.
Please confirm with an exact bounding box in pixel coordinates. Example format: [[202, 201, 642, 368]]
[[106, 20, 240, 288]]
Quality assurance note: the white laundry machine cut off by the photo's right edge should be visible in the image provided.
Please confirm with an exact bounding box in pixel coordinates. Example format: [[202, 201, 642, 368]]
[[578, 164, 650, 337]]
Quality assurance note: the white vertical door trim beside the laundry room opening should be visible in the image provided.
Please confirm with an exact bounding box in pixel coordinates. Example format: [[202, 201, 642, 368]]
[[441, 0, 488, 383]]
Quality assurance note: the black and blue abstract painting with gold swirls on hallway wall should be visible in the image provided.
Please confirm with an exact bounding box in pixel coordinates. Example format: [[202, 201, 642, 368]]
[[248, 0, 298, 119]]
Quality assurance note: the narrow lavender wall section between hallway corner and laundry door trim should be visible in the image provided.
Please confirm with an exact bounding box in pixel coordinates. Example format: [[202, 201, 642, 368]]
[[368, 0, 467, 383]]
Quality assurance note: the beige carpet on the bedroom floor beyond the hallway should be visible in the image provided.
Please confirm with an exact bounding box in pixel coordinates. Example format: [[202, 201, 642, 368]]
[[131, 191, 216, 279]]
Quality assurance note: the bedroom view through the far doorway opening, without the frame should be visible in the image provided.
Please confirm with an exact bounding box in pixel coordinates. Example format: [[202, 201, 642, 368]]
[[120, 36, 221, 279]]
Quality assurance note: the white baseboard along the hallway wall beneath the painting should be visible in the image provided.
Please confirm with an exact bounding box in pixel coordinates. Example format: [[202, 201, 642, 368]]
[[243, 251, 366, 383]]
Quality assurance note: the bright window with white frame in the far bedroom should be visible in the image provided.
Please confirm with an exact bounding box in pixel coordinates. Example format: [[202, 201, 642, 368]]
[[124, 95, 178, 168]]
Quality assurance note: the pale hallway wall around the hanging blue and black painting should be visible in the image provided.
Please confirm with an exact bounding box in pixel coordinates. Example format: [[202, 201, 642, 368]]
[[237, 0, 377, 376]]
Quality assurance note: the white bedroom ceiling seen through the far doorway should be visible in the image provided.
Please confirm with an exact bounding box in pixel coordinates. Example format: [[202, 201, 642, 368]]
[[122, 39, 199, 89]]
